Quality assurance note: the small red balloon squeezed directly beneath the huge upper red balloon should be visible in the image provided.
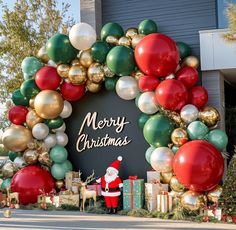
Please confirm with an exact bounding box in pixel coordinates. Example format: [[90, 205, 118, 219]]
[[138, 76, 160, 92]]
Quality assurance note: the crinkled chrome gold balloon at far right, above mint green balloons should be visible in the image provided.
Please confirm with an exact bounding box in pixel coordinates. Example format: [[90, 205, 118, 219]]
[[198, 106, 220, 127]]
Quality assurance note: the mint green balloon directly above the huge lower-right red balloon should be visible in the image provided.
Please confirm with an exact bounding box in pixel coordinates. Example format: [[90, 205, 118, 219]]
[[187, 121, 209, 140]]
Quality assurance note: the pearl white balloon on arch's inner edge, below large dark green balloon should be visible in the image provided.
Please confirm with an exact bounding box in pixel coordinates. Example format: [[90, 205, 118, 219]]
[[116, 76, 139, 100]]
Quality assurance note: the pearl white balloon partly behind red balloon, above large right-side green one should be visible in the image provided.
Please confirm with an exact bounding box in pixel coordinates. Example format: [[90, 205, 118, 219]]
[[138, 92, 158, 114]]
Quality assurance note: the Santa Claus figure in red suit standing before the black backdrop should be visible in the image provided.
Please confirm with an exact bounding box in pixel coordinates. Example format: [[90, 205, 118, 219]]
[[97, 156, 123, 214]]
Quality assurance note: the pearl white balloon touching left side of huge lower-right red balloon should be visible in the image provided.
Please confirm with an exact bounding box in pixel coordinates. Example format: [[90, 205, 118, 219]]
[[150, 147, 174, 172]]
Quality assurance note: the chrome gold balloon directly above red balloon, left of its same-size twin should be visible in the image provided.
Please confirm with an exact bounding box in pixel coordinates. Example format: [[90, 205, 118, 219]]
[[69, 64, 87, 85]]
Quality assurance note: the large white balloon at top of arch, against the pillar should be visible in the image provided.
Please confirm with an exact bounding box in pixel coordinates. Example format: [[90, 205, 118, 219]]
[[69, 22, 97, 50]]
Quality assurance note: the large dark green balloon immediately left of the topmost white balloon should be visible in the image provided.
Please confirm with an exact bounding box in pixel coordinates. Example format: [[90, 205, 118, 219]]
[[46, 34, 78, 64]]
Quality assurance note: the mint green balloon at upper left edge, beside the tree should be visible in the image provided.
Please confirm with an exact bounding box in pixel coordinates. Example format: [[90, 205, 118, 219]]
[[21, 57, 43, 76]]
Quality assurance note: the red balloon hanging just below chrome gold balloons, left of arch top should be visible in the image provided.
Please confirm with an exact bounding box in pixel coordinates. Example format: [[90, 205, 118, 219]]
[[61, 81, 85, 101]]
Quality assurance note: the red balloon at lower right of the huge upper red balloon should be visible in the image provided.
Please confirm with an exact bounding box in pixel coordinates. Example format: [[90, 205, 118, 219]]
[[175, 66, 198, 89]]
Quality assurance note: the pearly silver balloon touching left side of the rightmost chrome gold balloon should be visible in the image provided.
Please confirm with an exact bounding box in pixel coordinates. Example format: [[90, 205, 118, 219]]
[[180, 104, 199, 124]]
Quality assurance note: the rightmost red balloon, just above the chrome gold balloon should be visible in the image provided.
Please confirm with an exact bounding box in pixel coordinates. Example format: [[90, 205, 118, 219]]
[[188, 86, 208, 109]]
